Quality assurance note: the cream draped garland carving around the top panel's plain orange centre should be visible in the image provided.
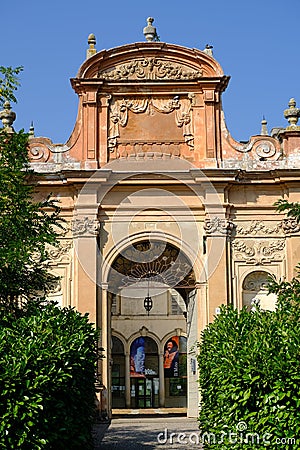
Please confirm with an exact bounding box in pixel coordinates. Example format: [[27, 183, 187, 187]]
[[108, 95, 194, 152]]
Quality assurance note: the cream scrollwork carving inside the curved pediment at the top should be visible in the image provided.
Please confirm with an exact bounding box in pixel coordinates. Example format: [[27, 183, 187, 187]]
[[98, 58, 202, 81]]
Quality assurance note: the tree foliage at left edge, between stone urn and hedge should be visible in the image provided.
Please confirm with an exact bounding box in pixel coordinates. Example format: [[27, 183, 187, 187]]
[[0, 131, 62, 307]]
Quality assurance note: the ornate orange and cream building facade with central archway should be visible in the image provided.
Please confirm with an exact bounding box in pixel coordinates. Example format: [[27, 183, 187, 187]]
[[2, 20, 300, 416]]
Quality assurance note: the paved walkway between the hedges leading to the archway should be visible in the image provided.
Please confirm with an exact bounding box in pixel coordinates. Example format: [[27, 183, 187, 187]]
[[96, 416, 202, 450]]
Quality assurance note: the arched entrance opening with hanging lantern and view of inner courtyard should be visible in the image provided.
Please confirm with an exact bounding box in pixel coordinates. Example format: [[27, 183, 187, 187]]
[[107, 239, 199, 411]]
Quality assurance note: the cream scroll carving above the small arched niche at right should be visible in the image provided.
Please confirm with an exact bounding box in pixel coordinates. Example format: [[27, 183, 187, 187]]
[[232, 239, 285, 264]]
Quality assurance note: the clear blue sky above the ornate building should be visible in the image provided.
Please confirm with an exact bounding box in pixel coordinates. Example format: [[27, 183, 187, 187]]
[[0, 0, 300, 142]]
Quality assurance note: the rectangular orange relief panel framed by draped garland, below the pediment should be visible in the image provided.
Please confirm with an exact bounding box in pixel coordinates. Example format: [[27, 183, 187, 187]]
[[108, 94, 194, 158]]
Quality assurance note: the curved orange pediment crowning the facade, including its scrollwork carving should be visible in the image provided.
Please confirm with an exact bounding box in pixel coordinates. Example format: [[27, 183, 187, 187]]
[[77, 42, 223, 81]]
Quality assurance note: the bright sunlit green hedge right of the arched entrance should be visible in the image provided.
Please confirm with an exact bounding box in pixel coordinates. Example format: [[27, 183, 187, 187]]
[[198, 300, 300, 450]]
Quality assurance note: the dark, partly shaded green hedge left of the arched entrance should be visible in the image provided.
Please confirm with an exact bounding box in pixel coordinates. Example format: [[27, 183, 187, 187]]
[[0, 303, 98, 450]]
